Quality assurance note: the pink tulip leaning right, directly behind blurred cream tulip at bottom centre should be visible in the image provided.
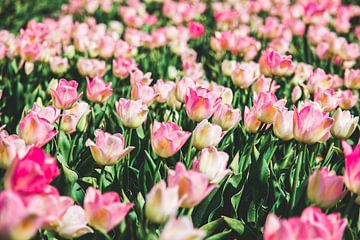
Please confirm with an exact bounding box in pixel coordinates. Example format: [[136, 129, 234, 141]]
[[168, 162, 216, 208]]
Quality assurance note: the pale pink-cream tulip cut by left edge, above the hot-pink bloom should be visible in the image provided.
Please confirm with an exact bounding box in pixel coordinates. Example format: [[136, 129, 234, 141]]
[[0, 130, 28, 169]]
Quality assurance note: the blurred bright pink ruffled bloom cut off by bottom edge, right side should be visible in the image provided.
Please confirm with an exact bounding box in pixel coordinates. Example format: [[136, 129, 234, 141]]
[[264, 207, 347, 240]]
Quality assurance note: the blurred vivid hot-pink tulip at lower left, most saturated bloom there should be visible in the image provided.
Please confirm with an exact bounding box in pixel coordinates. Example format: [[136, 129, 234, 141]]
[[5, 147, 60, 194]]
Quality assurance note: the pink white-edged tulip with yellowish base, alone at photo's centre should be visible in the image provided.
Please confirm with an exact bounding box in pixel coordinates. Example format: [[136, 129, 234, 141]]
[[151, 120, 191, 158]]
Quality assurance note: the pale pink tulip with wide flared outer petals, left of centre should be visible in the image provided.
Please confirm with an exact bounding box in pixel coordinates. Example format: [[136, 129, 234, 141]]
[[85, 129, 135, 165]]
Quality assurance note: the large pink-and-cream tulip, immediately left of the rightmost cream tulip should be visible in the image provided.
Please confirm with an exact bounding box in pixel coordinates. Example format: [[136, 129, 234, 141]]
[[293, 105, 334, 144]]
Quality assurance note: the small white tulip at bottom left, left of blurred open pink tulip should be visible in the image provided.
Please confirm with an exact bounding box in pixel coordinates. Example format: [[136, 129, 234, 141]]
[[56, 205, 94, 239]]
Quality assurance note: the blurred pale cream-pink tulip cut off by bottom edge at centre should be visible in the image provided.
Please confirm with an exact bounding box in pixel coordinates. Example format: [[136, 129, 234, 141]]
[[159, 217, 206, 240]]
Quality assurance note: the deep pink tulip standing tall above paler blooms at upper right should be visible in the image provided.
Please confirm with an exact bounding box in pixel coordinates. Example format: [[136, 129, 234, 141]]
[[259, 49, 294, 76]]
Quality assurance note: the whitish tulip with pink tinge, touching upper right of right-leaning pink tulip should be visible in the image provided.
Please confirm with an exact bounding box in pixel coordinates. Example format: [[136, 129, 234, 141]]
[[193, 147, 231, 184]]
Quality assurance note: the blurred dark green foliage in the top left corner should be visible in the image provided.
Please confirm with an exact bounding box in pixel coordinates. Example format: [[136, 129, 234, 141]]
[[0, 0, 66, 32]]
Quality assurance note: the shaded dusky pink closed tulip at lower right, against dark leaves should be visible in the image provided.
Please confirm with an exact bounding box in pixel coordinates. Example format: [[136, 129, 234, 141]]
[[307, 168, 346, 208]]
